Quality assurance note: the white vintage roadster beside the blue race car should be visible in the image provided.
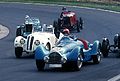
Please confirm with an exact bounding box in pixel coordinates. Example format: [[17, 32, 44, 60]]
[[14, 24, 63, 58]]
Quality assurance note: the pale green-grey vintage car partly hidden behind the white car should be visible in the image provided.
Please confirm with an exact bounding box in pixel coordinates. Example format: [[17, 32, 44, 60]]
[[16, 15, 41, 38]]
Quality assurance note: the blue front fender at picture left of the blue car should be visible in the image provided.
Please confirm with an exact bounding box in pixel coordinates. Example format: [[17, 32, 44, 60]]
[[35, 44, 49, 60]]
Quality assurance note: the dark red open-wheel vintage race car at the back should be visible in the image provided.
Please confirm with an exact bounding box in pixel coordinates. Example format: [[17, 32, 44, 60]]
[[53, 11, 83, 32]]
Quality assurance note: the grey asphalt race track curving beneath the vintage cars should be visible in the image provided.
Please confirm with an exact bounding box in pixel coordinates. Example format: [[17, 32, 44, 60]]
[[0, 3, 120, 81]]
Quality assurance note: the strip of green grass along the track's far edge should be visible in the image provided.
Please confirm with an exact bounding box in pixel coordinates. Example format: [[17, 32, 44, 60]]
[[0, 0, 120, 12]]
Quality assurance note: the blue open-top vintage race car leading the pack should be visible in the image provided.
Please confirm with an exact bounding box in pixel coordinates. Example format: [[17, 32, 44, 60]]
[[35, 36, 101, 71]]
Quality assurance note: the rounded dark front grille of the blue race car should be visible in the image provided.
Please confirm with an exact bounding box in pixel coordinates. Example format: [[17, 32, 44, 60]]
[[49, 52, 62, 64]]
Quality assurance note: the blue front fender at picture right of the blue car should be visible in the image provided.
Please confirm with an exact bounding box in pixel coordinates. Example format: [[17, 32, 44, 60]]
[[67, 46, 81, 61]]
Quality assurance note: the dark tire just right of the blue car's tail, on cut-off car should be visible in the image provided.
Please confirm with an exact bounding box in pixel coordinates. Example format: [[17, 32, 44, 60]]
[[101, 39, 110, 57]]
